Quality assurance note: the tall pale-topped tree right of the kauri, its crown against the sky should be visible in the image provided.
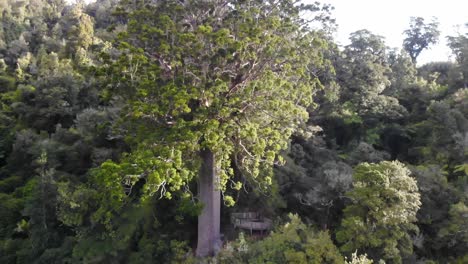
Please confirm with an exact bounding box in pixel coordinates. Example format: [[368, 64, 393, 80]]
[[338, 30, 405, 122]]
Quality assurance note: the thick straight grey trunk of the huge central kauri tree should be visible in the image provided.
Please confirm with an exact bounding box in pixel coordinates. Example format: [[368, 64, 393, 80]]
[[196, 150, 221, 257]]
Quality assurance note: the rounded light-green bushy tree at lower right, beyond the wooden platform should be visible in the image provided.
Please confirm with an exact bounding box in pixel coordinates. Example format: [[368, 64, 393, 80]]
[[336, 161, 421, 263]]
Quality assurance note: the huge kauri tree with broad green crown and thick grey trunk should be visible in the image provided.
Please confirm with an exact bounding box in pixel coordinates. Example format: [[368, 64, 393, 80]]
[[94, 0, 326, 256]]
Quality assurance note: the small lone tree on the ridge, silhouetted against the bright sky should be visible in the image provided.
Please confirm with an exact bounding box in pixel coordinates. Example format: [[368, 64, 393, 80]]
[[403, 17, 440, 64]]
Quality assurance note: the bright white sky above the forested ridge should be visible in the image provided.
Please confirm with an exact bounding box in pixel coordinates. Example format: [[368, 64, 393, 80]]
[[318, 0, 468, 65]]
